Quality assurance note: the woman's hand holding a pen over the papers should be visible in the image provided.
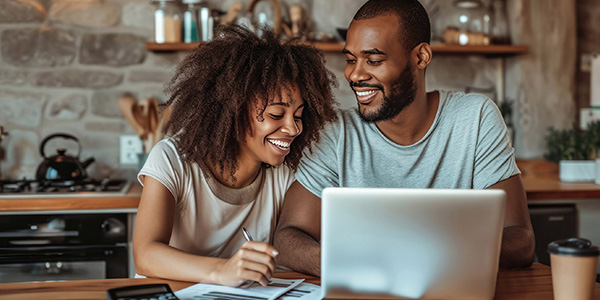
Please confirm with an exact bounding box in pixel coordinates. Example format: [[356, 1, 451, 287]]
[[210, 242, 279, 287]]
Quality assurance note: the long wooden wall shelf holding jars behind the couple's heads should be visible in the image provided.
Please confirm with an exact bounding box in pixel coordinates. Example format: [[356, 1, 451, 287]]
[[146, 42, 529, 55]]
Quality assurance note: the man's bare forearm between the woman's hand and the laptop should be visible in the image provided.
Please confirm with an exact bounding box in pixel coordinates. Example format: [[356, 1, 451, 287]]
[[273, 227, 321, 277]]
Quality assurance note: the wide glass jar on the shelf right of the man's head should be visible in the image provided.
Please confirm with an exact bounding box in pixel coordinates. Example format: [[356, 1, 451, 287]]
[[443, 0, 491, 45]]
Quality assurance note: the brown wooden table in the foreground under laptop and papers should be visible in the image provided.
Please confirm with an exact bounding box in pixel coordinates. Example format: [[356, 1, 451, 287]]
[[0, 263, 600, 300]]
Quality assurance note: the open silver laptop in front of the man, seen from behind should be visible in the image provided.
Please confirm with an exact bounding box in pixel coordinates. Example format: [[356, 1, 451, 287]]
[[321, 188, 506, 299]]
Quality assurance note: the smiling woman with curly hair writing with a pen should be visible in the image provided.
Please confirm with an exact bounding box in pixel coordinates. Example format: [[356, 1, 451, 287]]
[[133, 26, 336, 286]]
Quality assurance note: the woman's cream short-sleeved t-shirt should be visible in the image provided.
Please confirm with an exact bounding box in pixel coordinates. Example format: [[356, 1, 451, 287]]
[[137, 139, 294, 258]]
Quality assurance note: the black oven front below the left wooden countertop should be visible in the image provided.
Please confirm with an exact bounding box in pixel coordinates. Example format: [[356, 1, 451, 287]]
[[0, 213, 128, 282]]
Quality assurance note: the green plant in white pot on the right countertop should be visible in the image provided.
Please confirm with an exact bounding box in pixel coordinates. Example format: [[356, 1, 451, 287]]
[[544, 123, 600, 182]]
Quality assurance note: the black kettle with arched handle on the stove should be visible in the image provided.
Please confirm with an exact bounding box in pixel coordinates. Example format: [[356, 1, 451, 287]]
[[35, 133, 94, 181]]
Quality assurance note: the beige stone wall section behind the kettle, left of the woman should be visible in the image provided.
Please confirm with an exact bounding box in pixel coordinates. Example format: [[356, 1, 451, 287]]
[[0, 0, 184, 179]]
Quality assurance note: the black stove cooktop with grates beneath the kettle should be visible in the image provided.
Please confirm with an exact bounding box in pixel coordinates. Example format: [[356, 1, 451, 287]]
[[0, 178, 131, 199]]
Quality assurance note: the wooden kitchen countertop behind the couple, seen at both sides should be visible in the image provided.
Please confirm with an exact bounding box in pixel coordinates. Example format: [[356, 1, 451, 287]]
[[0, 160, 600, 213]]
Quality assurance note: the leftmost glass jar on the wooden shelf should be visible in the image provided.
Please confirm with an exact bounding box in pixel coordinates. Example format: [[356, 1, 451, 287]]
[[152, 0, 182, 43]]
